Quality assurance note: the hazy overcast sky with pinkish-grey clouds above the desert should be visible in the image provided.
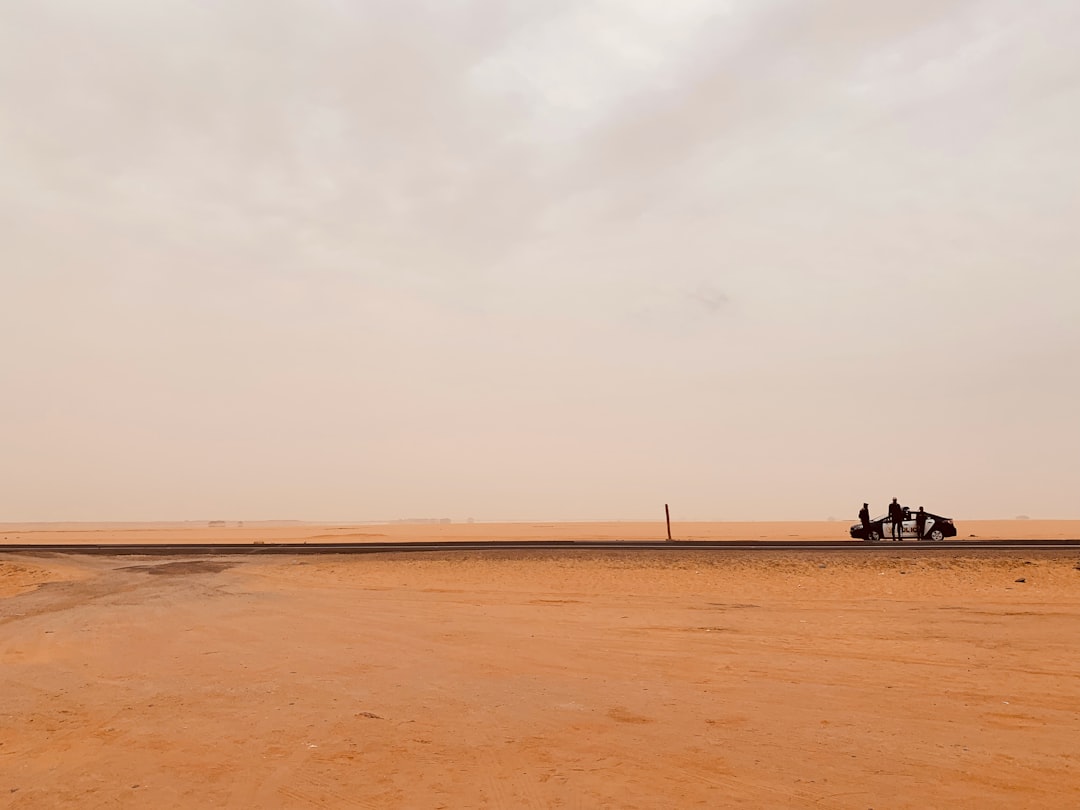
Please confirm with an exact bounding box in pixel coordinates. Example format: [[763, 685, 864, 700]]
[[0, 0, 1080, 521]]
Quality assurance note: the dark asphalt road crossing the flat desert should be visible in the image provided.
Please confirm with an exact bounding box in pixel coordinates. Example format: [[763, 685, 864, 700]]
[[0, 539, 1080, 556]]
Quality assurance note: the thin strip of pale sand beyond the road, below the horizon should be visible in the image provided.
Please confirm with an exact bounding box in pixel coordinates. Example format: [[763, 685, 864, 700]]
[[0, 518, 1080, 543]]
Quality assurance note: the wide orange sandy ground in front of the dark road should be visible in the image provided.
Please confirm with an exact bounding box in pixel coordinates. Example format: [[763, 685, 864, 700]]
[[0, 550, 1080, 810]]
